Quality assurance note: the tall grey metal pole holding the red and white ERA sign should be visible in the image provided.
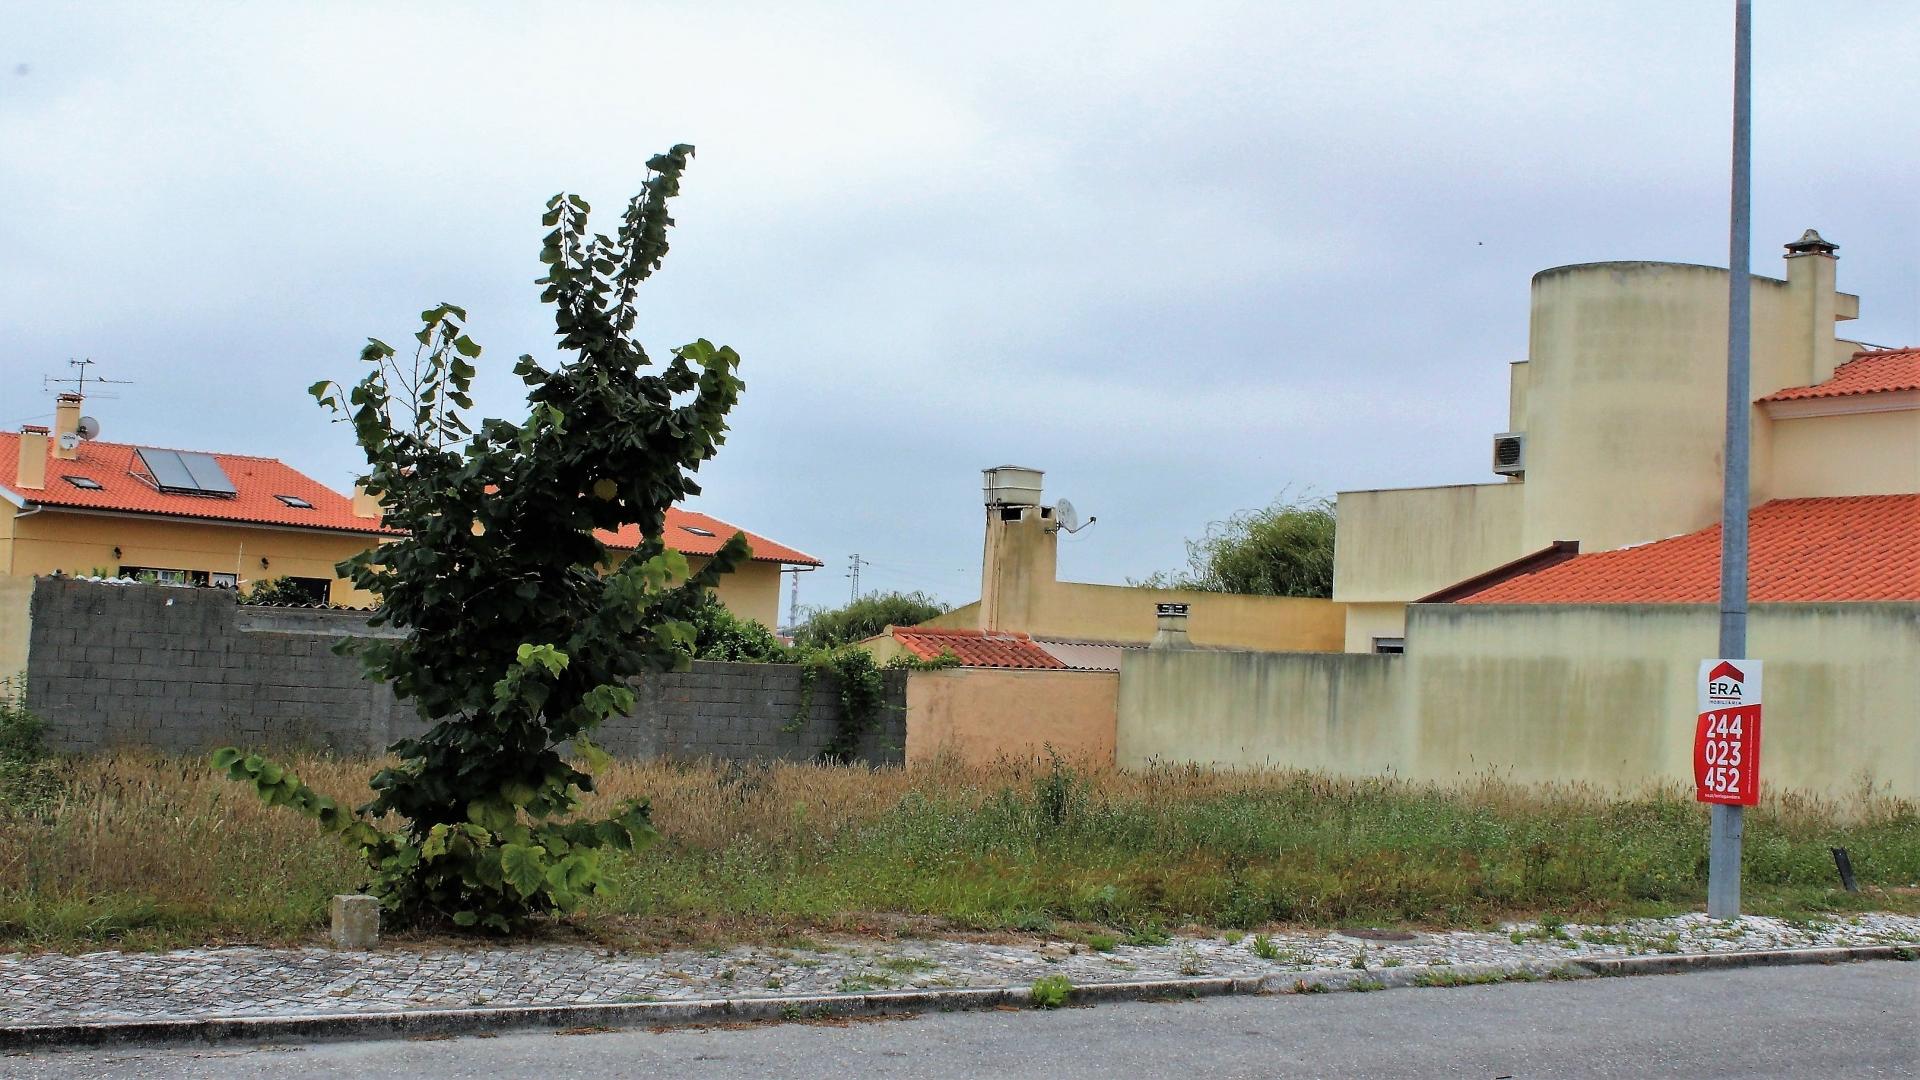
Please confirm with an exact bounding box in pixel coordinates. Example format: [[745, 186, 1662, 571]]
[[1707, 0, 1753, 919]]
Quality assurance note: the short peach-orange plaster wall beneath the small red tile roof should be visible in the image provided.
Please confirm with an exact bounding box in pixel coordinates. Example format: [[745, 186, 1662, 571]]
[[906, 667, 1119, 767]]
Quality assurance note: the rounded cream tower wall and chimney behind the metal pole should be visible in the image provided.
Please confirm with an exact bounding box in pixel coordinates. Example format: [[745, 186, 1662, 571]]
[[1523, 256, 1857, 552]]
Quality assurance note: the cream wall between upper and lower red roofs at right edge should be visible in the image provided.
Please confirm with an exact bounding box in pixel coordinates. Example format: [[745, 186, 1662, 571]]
[[1772, 409, 1920, 500]]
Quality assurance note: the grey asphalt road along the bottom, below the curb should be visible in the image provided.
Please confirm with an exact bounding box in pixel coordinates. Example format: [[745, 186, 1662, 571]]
[[0, 963, 1920, 1080]]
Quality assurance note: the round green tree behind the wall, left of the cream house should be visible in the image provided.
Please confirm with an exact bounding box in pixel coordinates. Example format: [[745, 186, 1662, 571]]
[[1133, 492, 1334, 598]]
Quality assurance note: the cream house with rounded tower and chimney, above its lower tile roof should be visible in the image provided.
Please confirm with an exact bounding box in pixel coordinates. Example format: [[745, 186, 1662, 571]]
[[1334, 229, 1920, 651]]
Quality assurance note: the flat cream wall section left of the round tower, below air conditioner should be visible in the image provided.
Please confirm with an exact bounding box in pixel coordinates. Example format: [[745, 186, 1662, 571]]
[[1332, 482, 1546, 603]]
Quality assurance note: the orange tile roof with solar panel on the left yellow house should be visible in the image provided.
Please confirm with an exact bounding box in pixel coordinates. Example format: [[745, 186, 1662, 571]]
[[0, 432, 822, 567]]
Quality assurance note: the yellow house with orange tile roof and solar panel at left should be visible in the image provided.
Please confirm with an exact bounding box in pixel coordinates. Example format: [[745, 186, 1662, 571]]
[[0, 394, 820, 671]]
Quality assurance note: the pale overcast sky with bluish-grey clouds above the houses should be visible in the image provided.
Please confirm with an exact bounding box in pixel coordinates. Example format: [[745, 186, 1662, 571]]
[[0, 0, 1920, 603]]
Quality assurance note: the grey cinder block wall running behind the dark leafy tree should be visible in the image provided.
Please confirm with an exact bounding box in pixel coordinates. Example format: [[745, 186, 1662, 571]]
[[27, 578, 906, 765]]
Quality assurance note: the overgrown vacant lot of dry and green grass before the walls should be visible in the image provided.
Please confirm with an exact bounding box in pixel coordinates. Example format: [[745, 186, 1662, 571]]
[[0, 755, 1920, 949]]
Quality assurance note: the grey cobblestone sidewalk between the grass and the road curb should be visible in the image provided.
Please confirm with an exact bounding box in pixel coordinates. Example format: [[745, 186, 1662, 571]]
[[0, 915, 1920, 1024]]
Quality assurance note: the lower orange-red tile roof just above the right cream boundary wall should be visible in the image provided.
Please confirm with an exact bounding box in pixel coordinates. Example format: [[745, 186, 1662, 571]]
[[1457, 494, 1920, 603]]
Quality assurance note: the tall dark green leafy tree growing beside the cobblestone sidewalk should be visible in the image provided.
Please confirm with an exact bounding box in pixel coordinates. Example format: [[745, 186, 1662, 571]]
[[215, 146, 747, 930]]
